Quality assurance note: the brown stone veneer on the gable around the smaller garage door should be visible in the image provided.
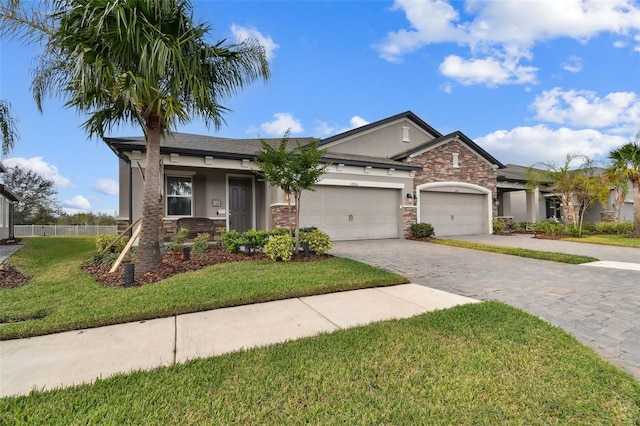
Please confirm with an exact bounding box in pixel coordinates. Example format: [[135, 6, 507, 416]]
[[407, 140, 498, 217]]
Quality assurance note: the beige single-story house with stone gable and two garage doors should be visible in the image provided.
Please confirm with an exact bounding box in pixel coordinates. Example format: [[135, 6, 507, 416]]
[[105, 111, 504, 240]]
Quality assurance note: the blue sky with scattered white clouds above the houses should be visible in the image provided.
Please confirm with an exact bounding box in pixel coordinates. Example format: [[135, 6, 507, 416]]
[[0, 0, 640, 214]]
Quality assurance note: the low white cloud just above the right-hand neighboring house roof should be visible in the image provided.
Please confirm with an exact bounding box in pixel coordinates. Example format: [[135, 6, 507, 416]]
[[474, 124, 629, 166]]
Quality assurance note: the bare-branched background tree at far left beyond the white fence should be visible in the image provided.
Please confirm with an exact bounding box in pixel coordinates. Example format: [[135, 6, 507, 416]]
[[4, 166, 62, 225]]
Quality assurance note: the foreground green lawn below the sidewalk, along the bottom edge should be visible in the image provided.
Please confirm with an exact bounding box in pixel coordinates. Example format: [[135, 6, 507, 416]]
[[0, 302, 640, 425]]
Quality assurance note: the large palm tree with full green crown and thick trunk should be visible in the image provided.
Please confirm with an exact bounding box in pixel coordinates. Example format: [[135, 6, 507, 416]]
[[25, 0, 269, 275]]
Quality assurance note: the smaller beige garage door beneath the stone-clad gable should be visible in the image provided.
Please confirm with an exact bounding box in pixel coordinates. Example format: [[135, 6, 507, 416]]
[[420, 191, 487, 236]]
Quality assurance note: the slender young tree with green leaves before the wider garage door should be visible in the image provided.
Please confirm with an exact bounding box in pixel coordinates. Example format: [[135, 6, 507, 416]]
[[255, 131, 327, 253]]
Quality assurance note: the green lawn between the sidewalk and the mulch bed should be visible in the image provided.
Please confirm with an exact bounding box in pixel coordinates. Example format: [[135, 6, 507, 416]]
[[0, 237, 407, 340]]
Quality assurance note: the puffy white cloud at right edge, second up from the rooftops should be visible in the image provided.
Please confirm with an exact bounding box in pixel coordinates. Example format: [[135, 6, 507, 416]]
[[532, 87, 640, 132]]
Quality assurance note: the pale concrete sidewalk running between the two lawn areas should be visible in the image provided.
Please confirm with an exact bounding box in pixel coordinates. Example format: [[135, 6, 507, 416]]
[[0, 284, 478, 397]]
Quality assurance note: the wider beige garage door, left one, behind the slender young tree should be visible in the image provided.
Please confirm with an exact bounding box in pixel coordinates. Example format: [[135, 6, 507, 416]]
[[300, 185, 400, 240]]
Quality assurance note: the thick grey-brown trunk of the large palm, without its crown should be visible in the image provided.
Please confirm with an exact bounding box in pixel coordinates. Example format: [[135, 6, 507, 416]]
[[135, 117, 162, 276]]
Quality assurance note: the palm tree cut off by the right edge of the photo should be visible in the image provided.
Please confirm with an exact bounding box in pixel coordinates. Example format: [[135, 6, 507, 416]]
[[607, 131, 640, 238]]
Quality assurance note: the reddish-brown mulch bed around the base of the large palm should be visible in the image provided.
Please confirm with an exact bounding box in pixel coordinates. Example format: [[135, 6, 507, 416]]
[[83, 245, 332, 287]]
